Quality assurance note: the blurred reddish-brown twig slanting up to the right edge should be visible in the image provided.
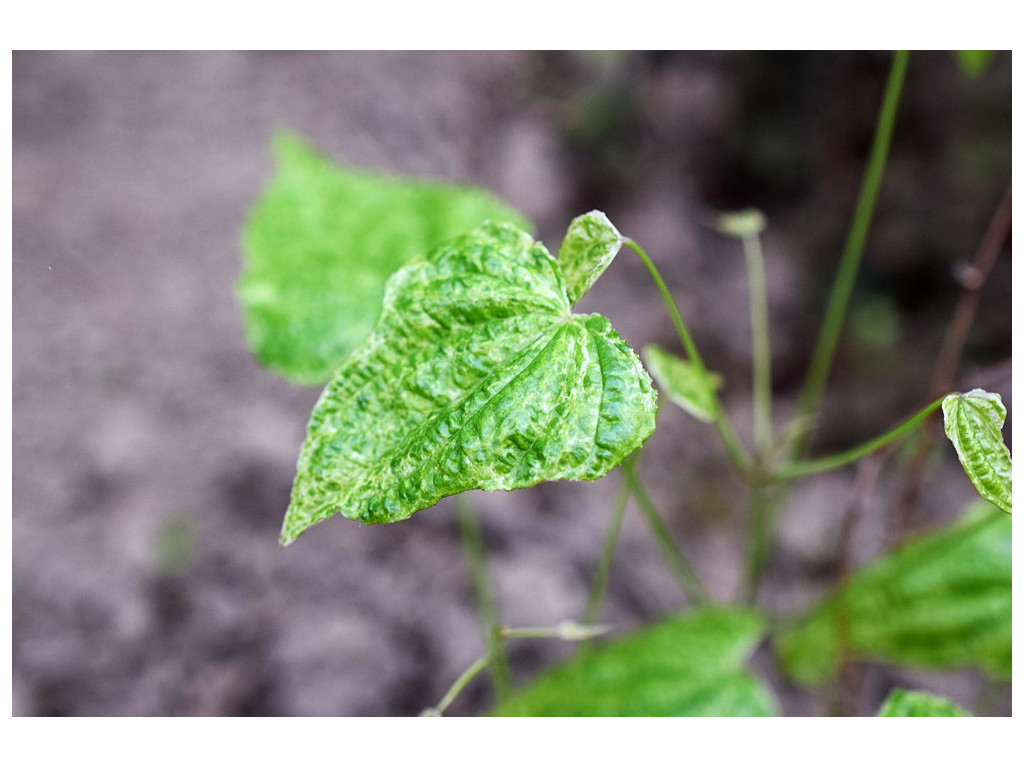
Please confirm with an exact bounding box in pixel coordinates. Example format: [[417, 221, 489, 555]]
[[889, 186, 1013, 546]]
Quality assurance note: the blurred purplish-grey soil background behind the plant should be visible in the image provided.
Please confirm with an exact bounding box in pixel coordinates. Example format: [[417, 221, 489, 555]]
[[12, 51, 1013, 716]]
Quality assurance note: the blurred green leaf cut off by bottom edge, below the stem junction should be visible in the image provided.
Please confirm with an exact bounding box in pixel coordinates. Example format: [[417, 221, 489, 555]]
[[495, 608, 778, 717]]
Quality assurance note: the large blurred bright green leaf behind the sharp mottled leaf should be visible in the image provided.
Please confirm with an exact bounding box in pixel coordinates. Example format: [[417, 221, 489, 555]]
[[239, 133, 529, 384]]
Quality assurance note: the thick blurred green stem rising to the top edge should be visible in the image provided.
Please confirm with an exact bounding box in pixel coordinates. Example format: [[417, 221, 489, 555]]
[[794, 51, 909, 448]]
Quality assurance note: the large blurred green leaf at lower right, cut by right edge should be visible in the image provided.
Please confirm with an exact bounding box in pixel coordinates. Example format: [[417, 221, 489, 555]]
[[777, 502, 1013, 683]]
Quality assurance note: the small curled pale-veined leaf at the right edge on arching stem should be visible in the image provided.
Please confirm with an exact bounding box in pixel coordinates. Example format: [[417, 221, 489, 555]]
[[942, 389, 1013, 513]]
